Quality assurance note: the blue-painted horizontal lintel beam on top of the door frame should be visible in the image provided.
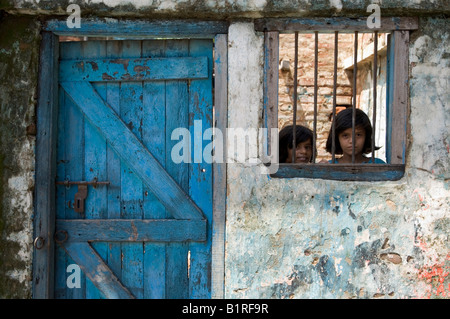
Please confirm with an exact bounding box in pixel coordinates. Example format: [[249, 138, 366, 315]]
[[43, 18, 228, 39]]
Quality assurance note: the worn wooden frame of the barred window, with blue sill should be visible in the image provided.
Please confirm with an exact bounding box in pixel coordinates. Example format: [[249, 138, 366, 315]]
[[255, 17, 418, 181]]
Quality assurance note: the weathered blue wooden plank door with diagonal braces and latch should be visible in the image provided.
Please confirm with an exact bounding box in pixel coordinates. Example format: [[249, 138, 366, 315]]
[[54, 39, 213, 298]]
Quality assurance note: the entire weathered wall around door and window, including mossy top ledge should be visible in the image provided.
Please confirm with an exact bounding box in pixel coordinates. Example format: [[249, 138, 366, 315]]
[[0, 0, 450, 298]]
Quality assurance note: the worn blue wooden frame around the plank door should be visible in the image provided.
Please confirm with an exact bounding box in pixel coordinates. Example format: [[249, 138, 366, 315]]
[[32, 19, 228, 299]]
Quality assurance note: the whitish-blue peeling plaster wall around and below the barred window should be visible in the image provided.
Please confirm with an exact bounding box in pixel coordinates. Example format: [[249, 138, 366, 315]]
[[225, 19, 450, 298]]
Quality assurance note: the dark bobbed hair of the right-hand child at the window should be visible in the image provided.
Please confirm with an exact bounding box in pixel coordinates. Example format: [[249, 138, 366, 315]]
[[325, 107, 380, 154]]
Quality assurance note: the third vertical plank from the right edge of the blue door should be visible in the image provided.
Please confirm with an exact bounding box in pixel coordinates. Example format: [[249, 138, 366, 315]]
[[142, 40, 170, 299]]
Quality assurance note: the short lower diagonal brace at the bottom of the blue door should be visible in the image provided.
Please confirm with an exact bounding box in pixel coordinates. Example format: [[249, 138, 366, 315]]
[[63, 242, 134, 299]]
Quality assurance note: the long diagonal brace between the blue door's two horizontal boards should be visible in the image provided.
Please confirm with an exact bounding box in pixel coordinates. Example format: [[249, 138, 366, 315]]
[[61, 82, 203, 219]]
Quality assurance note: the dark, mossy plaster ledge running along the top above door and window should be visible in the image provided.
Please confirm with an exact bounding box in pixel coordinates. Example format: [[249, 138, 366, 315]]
[[0, 0, 450, 19]]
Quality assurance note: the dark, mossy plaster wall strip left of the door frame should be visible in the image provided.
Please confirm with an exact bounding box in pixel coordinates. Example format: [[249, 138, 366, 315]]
[[0, 14, 40, 298]]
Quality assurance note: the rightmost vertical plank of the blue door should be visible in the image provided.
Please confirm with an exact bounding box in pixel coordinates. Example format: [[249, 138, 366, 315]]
[[189, 39, 213, 299]]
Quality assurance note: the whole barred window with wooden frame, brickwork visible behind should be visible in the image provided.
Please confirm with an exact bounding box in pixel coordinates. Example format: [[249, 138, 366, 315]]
[[255, 18, 418, 181]]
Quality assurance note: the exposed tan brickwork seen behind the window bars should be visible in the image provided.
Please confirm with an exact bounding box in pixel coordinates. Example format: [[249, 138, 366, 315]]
[[278, 34, 360, 160]]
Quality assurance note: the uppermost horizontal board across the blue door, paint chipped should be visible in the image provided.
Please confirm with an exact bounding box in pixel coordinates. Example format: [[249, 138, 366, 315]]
[[59, 57, 208, 82]]
